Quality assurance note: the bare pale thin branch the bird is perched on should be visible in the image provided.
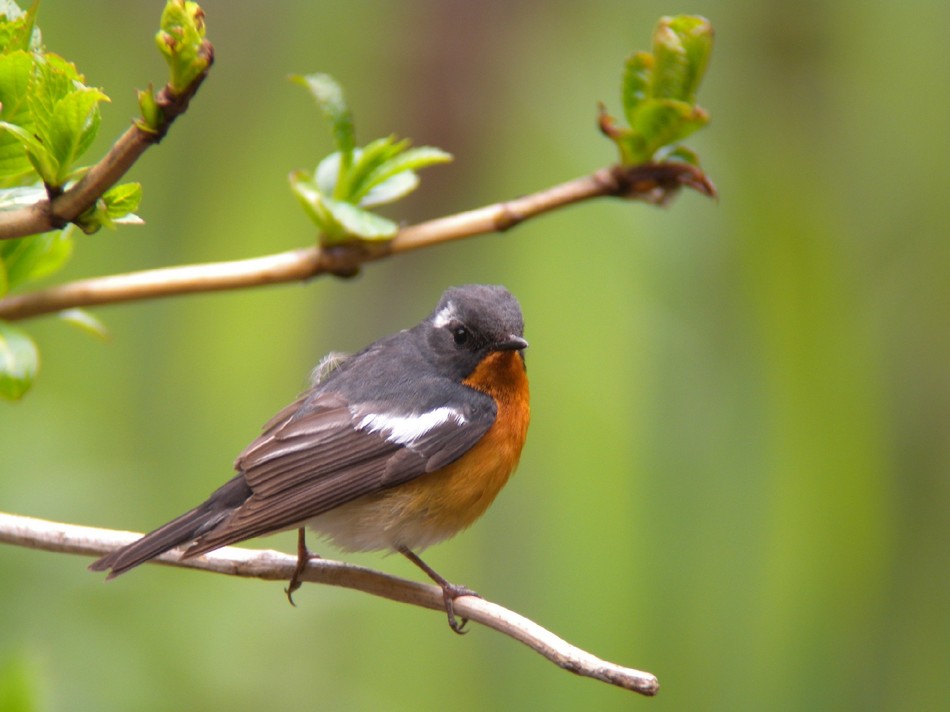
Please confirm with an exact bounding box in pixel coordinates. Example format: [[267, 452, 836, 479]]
[[0, 512, 659, 696]]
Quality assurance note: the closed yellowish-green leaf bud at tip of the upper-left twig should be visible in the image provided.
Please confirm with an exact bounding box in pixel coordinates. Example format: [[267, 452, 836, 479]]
[[155, 0, 210, 94]]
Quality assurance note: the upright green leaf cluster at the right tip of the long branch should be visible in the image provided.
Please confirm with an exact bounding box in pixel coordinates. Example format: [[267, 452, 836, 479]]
[[600, 15, 713, 166]]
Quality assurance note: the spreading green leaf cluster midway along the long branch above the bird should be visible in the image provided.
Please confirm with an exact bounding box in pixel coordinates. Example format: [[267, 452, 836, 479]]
[[290, 74, 452, 244]]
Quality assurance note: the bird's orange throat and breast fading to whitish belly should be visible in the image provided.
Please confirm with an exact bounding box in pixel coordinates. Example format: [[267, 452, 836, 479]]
[[315, 351, 530, 550]]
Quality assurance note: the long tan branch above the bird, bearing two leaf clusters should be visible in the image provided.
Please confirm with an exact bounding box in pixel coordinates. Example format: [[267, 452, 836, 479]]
[[0, 163, 715, 321]]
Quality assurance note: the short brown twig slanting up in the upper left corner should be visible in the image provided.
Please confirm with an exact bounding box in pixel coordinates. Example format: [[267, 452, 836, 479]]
[[0, 41, 214, 240]]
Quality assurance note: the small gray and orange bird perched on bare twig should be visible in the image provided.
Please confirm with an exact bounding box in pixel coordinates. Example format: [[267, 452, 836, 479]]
[[89, 284, 530, 633]]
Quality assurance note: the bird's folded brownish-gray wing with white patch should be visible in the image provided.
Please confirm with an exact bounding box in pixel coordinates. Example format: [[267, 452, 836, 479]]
[[187, 383, 497, 556]]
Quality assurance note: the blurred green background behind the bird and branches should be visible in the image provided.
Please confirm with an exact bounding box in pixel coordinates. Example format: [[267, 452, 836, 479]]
[[0, 0, 950, 711]]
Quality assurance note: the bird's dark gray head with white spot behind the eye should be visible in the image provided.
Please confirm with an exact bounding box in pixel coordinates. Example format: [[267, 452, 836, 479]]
[[420, 285, 528, 381]]
